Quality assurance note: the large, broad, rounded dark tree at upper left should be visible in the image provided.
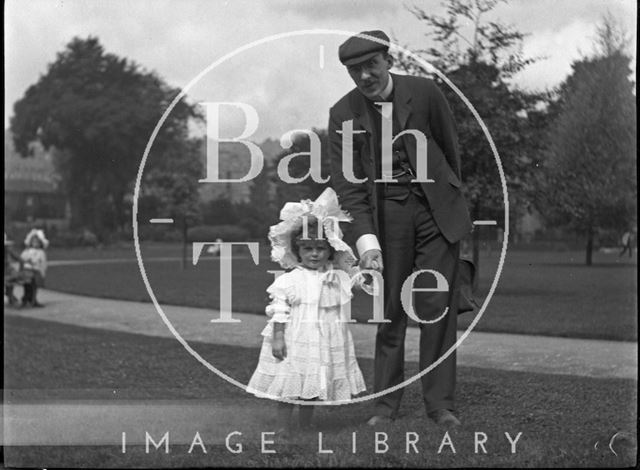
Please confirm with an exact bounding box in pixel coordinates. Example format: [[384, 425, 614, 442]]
[[11, 37, 197, 241]]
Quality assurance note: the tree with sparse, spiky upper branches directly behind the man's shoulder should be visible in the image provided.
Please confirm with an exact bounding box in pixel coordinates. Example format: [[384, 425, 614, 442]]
[[397, 0, 545, 280]]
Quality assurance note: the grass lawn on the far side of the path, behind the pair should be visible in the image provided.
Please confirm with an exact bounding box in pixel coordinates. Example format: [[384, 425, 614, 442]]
[[46, 245, 637, 341]]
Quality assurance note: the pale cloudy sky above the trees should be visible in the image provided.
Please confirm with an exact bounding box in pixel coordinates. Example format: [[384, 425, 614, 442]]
[[4, 0, 637, 141]]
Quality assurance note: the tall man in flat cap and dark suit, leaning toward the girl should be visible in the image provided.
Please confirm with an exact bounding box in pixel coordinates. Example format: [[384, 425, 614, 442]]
[[329, 31, 472, 426]]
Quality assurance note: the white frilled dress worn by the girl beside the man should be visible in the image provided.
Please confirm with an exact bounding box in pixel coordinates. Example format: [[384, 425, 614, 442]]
[[248, 266, 366, 401]]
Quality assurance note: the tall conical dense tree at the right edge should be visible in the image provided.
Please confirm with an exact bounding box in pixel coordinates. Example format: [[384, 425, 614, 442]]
[[537, 17, 637, 265]]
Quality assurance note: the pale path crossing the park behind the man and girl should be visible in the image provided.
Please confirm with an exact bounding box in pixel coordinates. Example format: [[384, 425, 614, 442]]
[[5, 289, 638, 380]]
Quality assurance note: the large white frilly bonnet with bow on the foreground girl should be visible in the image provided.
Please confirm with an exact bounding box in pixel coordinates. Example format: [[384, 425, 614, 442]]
[[269, 188, 356, 271]]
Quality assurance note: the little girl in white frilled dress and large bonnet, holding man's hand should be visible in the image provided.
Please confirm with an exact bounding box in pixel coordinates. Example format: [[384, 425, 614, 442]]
[[247, 188, 366, 435]]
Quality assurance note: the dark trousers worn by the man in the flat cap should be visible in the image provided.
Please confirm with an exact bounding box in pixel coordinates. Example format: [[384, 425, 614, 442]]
[[374, 192, 459, 417]]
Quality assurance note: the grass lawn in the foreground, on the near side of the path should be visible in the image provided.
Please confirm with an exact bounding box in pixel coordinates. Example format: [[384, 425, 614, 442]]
[[4, 315, 637, 468]]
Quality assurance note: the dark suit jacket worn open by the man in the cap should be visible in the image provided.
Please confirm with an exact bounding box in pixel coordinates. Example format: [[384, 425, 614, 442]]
[[329, 74, 472, 243]]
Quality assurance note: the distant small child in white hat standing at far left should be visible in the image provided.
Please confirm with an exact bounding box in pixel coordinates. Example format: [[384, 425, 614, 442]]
[[20, 229, 49, 307]]
